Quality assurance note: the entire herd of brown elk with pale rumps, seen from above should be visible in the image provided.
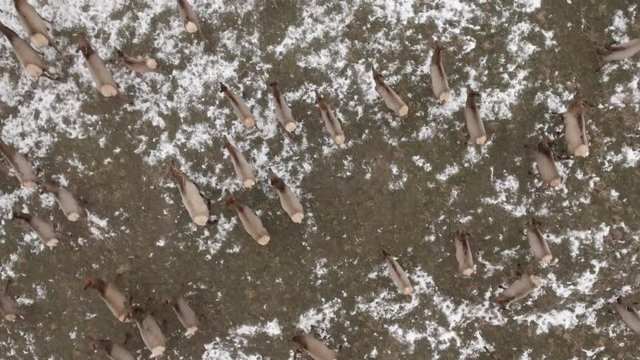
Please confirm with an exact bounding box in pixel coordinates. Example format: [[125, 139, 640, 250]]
[[0, 0, 640, 360]]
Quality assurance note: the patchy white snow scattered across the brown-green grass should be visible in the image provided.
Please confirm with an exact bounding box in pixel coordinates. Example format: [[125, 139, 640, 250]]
[[0, 0, 640, 360]]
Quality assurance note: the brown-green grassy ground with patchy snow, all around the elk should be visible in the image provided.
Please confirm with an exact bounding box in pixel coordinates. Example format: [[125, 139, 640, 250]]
[[0, 0, 640, 360]]
